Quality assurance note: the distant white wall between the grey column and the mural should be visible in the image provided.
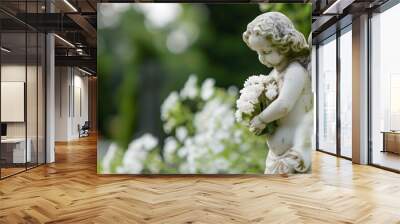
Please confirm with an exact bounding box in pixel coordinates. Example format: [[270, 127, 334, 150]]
[[55, 67, 88, 141]]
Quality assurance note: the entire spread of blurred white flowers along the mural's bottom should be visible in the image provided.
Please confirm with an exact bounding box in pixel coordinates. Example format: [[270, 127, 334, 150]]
[[102, 75, 267, 173]]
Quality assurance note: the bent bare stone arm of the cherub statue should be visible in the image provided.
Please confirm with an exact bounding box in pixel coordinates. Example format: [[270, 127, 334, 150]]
[[258, 62, 307, 123]]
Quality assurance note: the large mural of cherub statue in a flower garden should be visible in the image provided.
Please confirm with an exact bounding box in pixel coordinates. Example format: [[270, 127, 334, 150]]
[[97, 3, 314, 174]]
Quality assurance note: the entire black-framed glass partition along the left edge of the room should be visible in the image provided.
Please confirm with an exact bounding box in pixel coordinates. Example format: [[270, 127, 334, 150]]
[[0, 1, 46, 179]]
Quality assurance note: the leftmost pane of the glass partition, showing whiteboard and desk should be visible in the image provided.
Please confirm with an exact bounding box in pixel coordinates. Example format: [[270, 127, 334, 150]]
[[0, 31, 27, 177]]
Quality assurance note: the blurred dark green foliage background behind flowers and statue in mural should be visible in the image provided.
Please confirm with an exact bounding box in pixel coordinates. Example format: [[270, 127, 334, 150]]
[[97, 4, 311, 148]]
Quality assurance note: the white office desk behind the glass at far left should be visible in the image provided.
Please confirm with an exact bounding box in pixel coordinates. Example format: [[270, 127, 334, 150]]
[[1, 138, 32, 163]]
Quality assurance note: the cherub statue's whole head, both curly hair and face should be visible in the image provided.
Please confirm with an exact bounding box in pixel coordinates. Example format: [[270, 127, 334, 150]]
[[243, 12, 310, 67]]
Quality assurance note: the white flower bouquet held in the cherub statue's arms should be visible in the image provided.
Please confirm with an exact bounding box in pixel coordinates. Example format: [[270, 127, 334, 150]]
[[235, 75, 279, 135]]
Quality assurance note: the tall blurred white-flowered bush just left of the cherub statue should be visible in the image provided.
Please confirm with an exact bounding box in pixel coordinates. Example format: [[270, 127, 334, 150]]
[[162, 76, 267, 173]]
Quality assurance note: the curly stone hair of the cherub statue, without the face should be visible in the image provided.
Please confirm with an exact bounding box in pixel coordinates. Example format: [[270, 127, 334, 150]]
[[243, 12, 310, 58]]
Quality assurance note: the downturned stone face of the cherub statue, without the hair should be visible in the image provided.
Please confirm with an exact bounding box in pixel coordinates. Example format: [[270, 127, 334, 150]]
[[249, 34, 285, 68]]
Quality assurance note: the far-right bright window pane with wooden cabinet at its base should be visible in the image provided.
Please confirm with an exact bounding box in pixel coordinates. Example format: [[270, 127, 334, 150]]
[[370, 4, 400, 170]]
